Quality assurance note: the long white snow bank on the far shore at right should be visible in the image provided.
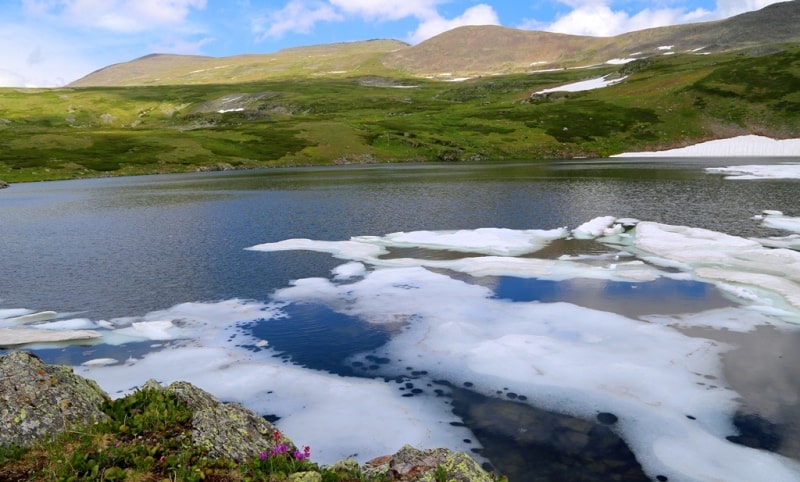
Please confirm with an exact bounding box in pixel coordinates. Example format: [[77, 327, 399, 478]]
[[611, 135, 800, 157]]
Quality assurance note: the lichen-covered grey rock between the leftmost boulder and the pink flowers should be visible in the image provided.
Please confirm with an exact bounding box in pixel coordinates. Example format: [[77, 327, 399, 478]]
[[162, 382, 296, 461]]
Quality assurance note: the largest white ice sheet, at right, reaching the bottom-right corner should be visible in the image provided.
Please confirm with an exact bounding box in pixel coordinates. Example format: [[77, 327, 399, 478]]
[[250, 217, 800, 481]]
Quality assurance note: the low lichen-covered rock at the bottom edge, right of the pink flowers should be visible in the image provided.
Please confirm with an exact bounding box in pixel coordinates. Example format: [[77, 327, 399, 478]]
[[363, 445, 494, 482]]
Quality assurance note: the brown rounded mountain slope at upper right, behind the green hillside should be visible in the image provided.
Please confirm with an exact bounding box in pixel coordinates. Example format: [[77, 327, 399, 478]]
[[383, 0, 800, 76]]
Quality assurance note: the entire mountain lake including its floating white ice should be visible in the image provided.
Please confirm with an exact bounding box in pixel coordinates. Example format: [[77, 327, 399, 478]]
[[0, 158, 800, 481]]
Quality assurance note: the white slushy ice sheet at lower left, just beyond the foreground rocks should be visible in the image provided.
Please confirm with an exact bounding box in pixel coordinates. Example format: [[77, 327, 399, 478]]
[[74, 310, 479, 464]]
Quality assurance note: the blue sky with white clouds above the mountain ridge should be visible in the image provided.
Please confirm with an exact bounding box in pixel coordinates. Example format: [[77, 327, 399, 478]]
[[0, 0, 778, 87]]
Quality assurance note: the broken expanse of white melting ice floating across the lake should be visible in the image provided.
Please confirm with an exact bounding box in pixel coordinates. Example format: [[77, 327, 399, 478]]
[[0, 217, 800, 481]]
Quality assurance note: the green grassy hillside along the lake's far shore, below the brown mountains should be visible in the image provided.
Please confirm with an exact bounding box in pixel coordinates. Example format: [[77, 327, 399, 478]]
[[0, 44, 800, 182]]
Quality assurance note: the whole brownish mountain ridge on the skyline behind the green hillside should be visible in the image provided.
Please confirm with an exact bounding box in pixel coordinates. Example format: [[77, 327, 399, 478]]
[[68, 0, 800, 87]]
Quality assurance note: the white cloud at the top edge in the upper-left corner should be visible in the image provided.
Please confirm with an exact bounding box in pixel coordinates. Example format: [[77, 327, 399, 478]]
[[23, 0, 206, 33]]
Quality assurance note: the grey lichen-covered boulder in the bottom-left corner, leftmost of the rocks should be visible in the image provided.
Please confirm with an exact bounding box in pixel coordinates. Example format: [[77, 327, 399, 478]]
[[0, 352, 109, 446]]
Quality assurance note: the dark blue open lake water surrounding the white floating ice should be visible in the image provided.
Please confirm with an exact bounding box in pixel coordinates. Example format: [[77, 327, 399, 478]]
[[0, 159, 800, 480]]
